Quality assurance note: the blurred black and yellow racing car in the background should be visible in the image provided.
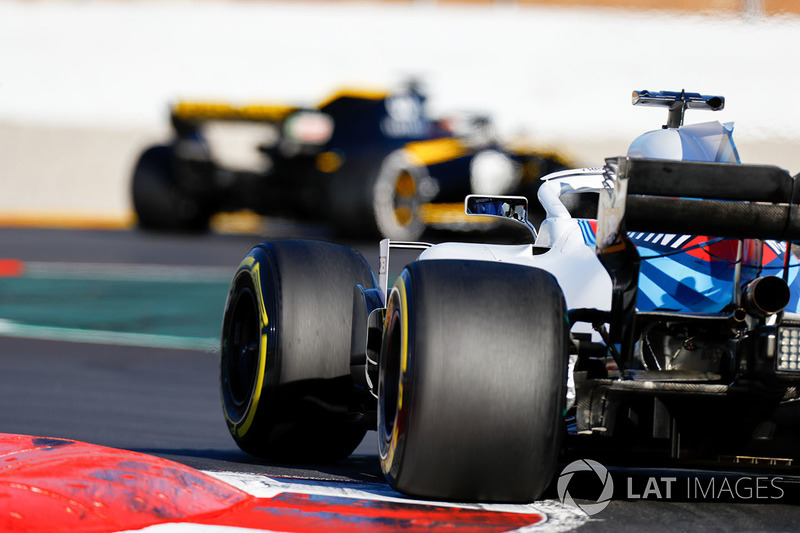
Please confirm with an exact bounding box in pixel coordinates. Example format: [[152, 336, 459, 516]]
[[132, 83, 570, 240]]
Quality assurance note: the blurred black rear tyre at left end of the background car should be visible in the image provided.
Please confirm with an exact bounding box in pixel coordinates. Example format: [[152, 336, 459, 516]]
[[131, 146, 211, 233]]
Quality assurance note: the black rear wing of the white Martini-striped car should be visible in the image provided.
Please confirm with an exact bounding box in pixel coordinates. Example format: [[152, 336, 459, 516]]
[[597, 157, 800, 253]]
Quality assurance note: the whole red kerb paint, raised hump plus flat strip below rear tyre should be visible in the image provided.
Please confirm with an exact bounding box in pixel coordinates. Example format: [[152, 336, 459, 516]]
[[0, 434, 544, 533]]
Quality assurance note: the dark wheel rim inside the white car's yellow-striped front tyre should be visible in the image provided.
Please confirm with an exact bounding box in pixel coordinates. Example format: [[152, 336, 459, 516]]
[[223, 287, 259, 408]]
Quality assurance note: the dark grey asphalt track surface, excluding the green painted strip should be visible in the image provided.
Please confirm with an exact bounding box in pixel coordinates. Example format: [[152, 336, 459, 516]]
[[0, 224, 800, 531]]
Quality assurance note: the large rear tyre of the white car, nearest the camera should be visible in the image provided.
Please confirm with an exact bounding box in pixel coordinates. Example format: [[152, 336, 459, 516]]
[[378, 260, 567, 502]]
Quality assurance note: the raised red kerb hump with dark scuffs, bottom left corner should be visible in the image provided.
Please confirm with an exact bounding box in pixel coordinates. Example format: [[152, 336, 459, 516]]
[[0, 435, 254, 532]]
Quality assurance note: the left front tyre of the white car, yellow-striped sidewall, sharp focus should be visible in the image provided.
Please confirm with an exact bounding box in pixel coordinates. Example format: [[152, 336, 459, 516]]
[[220, 240, 376, 462]]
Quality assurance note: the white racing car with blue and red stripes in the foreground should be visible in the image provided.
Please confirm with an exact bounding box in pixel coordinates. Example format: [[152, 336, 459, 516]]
[[220, 91, 800, 502]]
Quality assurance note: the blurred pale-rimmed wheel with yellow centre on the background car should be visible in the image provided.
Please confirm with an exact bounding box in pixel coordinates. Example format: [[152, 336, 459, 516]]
[[372, 150, 431, 241]]
